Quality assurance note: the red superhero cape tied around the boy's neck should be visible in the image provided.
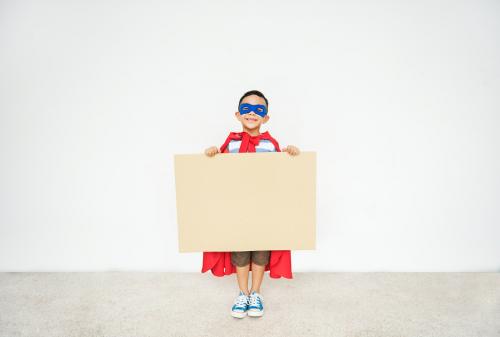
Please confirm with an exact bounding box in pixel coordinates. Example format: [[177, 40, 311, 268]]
[[201, 131, 292, 279]]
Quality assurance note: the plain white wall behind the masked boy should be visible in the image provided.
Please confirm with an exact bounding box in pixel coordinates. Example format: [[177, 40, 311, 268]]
[[0, 0, 500, 272]]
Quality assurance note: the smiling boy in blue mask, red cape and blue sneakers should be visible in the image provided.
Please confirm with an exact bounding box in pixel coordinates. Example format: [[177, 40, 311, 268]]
[[201, 90, 300, 318]]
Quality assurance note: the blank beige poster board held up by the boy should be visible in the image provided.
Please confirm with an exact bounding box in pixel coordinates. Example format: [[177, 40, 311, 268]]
[[174, 151, 316, 252]]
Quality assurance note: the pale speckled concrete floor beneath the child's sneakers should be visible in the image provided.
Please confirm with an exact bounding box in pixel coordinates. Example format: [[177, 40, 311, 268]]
[[0, 272, 500, 337]]
